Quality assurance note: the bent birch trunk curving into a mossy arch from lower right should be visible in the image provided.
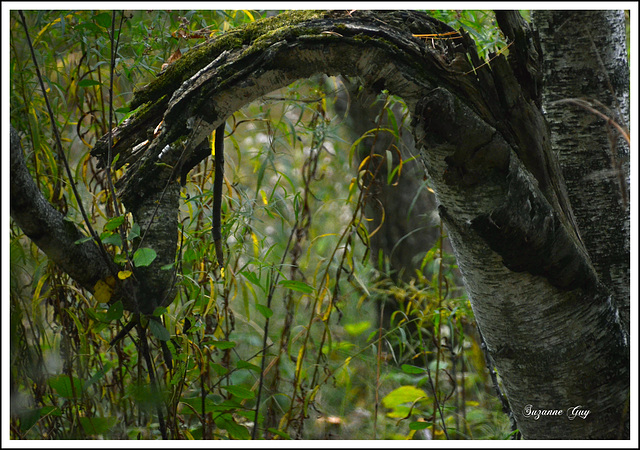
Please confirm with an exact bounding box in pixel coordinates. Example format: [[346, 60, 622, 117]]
[[15, 11, 629, 439]]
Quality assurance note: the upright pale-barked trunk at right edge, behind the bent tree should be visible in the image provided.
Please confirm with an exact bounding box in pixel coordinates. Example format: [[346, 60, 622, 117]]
[[532, 10, 631, 332]]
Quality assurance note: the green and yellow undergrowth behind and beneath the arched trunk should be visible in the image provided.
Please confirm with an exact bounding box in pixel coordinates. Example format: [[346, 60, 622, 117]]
[[10, 11, 508, 439]]
